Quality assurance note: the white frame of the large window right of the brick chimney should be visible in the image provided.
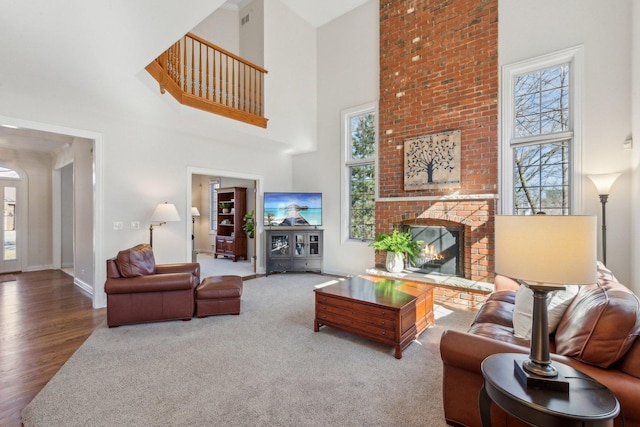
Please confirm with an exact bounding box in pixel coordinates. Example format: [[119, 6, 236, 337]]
[[499, 45, 584, 215]]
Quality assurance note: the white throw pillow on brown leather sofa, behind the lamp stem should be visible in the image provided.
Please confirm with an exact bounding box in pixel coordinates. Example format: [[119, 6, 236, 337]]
[[513, 285, 579, 340]]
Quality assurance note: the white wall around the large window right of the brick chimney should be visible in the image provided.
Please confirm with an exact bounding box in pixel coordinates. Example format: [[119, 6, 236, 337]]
[[498, 0, 638, 289]]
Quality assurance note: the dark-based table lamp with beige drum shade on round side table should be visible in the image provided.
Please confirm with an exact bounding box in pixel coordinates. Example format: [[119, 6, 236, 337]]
[[495, 215, 596, 392]]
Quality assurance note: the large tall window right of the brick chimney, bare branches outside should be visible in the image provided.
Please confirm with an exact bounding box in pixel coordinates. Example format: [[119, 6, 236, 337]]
[[502, 49, 581, 215]]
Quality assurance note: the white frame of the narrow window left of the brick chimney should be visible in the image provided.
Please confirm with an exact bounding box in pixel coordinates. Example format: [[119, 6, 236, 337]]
[[340, 102, 379, 246]]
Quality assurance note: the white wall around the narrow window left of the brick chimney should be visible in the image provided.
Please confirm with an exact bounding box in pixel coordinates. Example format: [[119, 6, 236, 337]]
[[293, 0, 379, 274]]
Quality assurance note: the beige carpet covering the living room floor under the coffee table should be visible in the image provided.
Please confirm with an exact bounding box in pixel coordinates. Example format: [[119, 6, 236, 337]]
[[23, 274, 473, 427]]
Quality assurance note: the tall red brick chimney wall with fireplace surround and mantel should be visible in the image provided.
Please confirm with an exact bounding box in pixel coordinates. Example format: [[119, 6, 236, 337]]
[[376, 0, 499, 281]]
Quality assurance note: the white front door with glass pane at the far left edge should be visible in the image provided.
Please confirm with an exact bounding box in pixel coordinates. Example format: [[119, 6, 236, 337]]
[[0, 181, 21, 272]]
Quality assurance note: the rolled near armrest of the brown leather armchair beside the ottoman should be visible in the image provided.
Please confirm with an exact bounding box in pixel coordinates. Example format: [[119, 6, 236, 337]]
[[104, 273, 193, 294]]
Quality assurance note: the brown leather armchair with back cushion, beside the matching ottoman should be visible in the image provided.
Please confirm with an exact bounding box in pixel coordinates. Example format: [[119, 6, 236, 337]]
[[104, 244, 200, 328]]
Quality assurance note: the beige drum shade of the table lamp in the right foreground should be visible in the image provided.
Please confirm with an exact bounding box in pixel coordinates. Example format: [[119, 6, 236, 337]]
[[495, 215, 597, 285]]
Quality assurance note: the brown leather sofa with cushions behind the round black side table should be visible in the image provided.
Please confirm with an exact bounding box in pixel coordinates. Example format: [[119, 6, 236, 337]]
[[440, 263, 640, 427]]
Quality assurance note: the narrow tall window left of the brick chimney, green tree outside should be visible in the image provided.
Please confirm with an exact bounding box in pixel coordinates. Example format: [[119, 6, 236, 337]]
[[342, 104, 377, 241]]
